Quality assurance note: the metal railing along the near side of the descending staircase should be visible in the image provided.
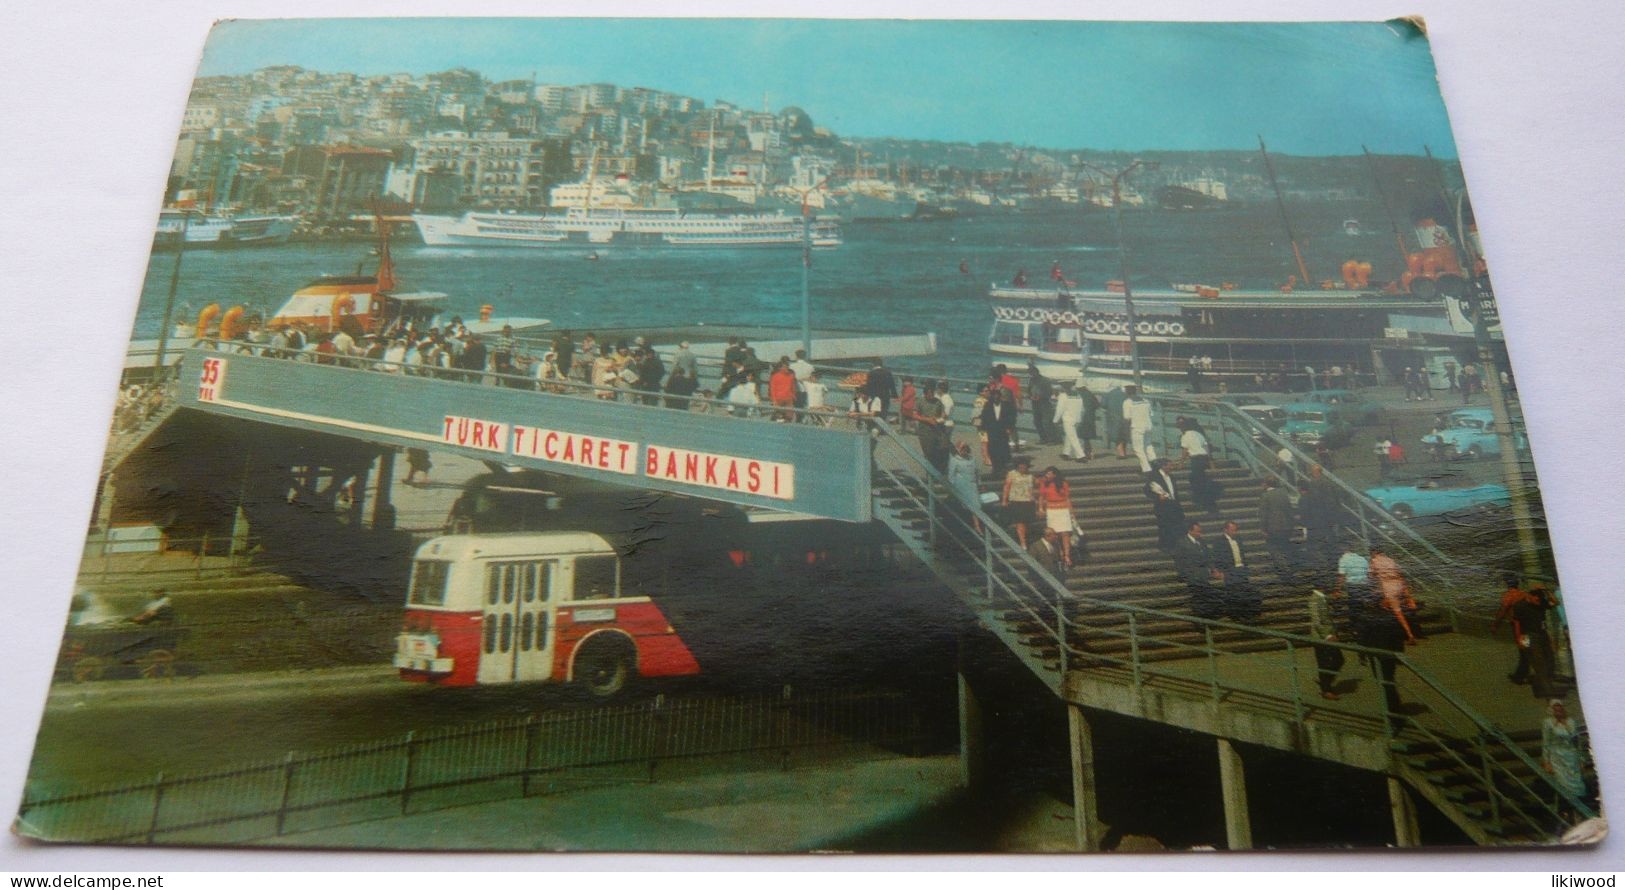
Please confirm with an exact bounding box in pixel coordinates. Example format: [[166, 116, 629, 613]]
[[873, 421, 1596, 832]]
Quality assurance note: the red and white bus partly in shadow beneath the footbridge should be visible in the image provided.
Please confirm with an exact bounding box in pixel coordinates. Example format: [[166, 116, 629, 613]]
[[393, 471, 952, 698]]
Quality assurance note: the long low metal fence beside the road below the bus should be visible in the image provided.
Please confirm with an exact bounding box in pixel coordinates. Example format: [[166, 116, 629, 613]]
[[18, 687, 926, 843]]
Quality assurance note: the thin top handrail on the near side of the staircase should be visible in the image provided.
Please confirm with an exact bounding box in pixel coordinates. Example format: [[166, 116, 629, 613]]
[[869, 417, 1596, 822]]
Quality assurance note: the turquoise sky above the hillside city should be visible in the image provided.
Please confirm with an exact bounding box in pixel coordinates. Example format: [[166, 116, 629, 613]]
[[198, 18, 1456, 158]]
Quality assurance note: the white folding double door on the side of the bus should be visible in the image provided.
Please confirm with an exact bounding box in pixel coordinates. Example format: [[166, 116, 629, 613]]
[[478, 559, 557, 684]]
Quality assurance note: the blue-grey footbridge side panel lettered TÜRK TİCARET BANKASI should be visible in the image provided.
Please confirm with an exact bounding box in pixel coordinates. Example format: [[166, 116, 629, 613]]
[[176, 349, 873, 521]]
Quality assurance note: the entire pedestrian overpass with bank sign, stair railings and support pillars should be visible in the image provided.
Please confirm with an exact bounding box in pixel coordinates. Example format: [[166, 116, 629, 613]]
[[149, 349, 1596, 849]]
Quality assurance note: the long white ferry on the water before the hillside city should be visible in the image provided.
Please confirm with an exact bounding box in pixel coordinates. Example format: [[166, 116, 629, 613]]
[[413, 208, 842, 250]]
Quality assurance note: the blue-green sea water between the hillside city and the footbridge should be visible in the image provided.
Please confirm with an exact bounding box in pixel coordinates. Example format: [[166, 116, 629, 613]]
[[133, 201, 1401, 375]]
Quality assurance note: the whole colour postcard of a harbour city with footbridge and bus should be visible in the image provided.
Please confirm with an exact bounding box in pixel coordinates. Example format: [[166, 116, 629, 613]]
[[15, 18, 1607, 853]]
